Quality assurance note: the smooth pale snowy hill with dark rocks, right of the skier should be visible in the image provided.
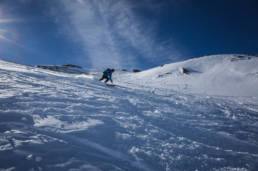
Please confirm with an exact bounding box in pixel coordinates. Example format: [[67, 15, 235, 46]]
[[119, 55, 258, 96]]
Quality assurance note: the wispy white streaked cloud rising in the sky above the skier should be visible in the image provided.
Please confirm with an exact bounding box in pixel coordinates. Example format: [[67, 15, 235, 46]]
[[60, 0, 180, 67]]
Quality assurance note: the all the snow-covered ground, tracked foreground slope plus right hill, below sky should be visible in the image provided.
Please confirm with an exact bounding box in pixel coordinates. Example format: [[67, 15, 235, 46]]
[[0, 55, 258, 171]]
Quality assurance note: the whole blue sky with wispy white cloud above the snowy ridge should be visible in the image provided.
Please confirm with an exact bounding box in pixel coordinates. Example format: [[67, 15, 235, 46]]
[[0, 0, 258, 69]]
